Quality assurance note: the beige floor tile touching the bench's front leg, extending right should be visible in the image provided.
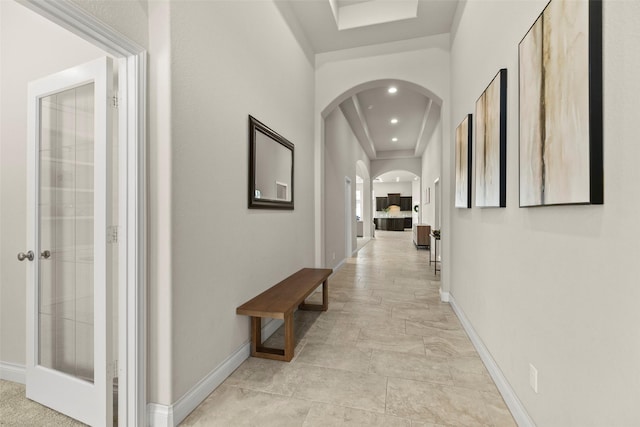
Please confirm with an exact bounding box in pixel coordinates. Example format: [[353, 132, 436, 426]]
[[297, 343, 372, 372]]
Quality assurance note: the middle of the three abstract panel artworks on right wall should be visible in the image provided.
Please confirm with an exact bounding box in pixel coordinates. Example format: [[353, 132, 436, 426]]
[[474, 68, 507, 208]]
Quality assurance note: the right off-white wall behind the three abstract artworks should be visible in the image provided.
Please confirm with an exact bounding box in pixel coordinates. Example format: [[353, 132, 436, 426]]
[[444, 0, 640, 427]]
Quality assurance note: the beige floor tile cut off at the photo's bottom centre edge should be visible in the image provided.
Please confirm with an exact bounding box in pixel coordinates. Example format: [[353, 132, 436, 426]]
[[303, 403, 411, 427]]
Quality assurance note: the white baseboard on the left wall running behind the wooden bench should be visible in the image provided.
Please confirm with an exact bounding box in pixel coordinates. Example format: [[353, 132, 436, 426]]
[[147, 319, 284, 427]]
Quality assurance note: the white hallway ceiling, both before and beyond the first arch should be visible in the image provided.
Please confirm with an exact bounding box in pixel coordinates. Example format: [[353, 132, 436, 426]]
[[280, 0, 459, 173]]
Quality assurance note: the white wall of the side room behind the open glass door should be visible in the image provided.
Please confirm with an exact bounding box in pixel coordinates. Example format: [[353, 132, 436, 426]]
[[0, 1, 105, 372]]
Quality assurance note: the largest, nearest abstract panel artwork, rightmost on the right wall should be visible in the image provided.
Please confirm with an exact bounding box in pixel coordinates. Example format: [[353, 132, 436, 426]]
[[519, 0, 604, 207]]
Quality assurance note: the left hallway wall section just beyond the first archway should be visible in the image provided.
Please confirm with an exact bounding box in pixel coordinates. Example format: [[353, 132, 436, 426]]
[[323, 108, 375, 268]]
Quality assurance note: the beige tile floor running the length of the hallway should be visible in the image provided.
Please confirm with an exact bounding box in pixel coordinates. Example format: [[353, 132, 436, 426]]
[[181, 231, 516, 427]]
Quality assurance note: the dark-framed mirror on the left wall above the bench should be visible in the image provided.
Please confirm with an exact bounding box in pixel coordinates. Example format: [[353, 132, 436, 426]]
[[249, 116, 294, 209]]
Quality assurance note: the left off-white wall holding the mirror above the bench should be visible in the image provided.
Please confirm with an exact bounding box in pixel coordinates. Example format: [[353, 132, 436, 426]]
[[165, 1, 316, 402]]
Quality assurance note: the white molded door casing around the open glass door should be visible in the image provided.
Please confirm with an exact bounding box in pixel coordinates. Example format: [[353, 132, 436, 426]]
[[18, 0, 147, 426]]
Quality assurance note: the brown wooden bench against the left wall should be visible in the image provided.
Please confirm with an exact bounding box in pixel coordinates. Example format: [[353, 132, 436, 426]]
[[236, 268, 333, 362]]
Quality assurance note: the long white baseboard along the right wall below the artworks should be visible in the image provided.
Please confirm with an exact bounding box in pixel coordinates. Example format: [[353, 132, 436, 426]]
[[450, 291, 536, 427]]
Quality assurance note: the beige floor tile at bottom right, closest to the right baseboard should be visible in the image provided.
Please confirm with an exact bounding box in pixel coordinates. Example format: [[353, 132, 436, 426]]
[[387, 378, 492, 427]]
